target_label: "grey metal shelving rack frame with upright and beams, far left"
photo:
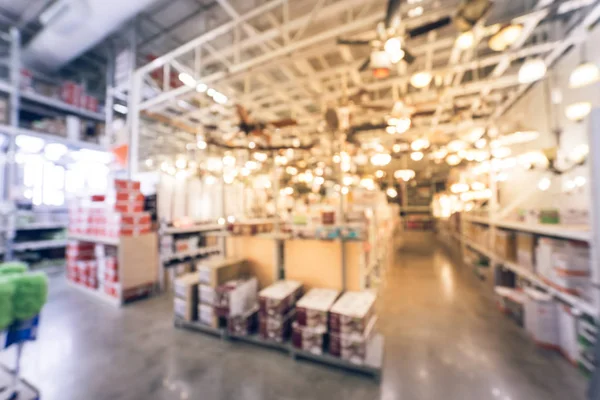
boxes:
[0,28,105,260]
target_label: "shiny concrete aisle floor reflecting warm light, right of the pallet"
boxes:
[381,237,587,400]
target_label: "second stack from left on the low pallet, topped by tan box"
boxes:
[196,258,246,328]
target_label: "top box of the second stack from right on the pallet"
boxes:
[296,289,340,331]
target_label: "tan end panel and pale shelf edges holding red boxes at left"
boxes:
[69,233,158,306]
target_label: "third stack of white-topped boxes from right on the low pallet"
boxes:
[258,281,302,343]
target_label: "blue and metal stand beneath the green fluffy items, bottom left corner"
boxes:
[0,316,40,400]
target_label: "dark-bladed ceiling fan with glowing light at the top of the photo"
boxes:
[337,0,491,78]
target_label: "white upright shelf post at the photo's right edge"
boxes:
[587,108,600,318]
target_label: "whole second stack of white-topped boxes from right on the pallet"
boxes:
[292,289,340,354]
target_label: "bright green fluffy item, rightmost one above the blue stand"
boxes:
[12,272,48,321]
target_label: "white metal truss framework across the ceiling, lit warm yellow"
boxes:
[130,0,598,170]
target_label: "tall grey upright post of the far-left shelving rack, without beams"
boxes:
[5,27,21,260]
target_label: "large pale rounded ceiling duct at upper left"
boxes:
[23,0,155,72]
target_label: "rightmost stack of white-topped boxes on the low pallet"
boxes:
[329,291,377,364]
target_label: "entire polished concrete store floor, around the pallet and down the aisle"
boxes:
[0,236,586,400]
